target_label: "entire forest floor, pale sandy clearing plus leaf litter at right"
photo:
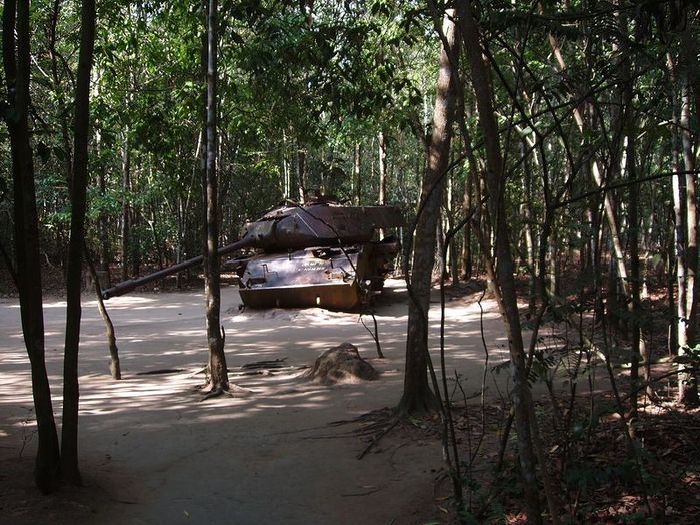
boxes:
[0,280,700,525]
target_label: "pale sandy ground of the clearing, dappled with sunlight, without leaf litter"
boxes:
[0,281,506,524]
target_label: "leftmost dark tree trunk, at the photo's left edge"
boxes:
[2,0,60,493]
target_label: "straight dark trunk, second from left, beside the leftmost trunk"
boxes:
[61,0,95,485]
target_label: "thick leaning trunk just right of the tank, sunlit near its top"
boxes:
[400,9,459,413]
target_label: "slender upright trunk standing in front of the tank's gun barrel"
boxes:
[204,0,229,392]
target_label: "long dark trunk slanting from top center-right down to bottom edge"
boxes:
[457,0,544,523]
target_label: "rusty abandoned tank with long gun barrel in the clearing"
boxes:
[102,197,403,311]
